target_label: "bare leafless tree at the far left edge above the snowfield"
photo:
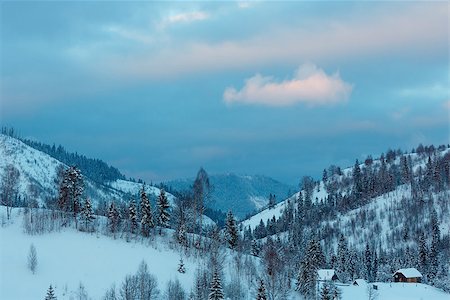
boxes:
[0,164,20,220]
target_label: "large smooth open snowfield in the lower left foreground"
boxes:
[0,207,196,300]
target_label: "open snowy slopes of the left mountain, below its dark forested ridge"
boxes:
[0,134,174,204]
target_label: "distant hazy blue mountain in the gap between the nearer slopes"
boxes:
[165,174,295,218]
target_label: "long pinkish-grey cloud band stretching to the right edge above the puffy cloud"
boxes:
[100,3,449,79]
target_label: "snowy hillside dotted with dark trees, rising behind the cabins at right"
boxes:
[237,145,450,299]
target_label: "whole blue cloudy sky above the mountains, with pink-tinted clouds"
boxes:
[0,1,450,184]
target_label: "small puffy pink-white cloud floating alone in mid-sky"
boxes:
[223,64,352,106]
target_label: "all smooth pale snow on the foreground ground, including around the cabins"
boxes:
[0,206,449,300]
